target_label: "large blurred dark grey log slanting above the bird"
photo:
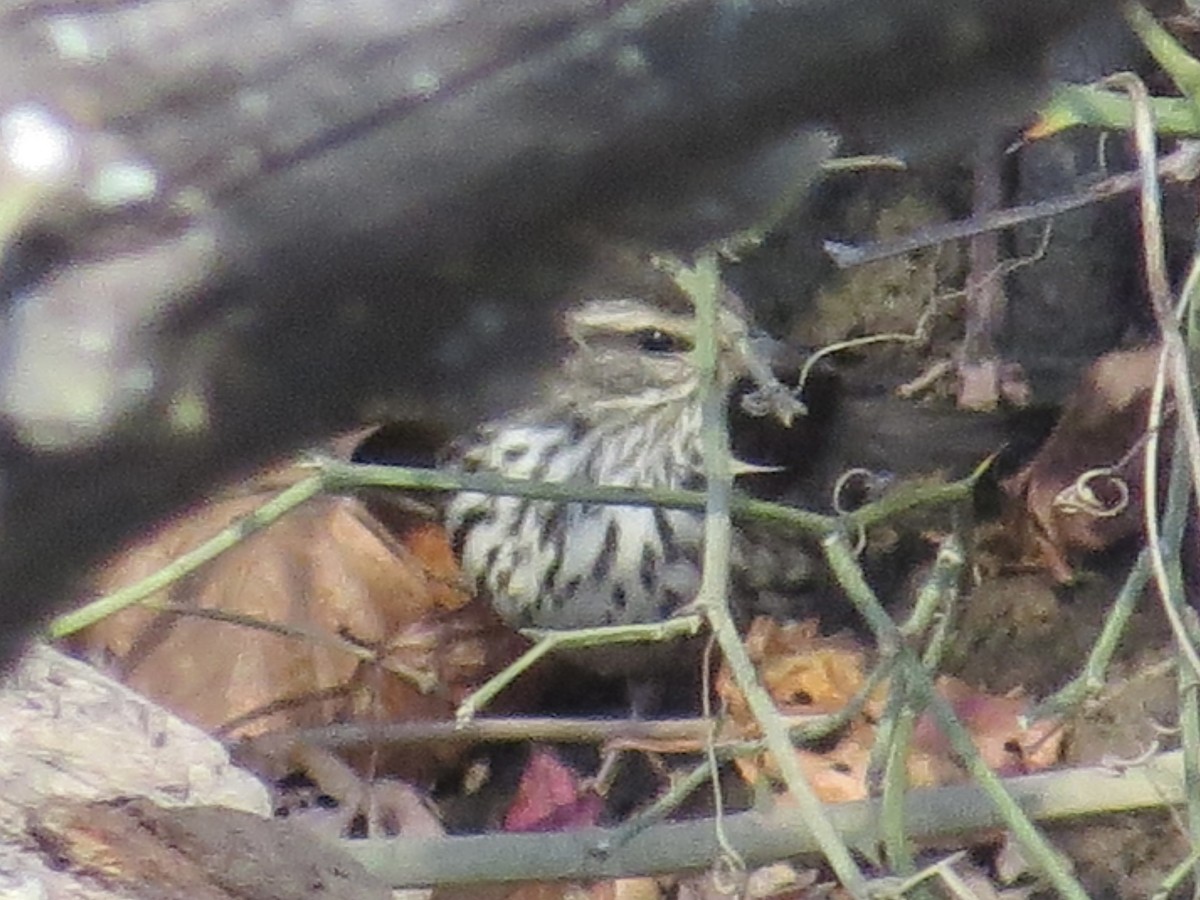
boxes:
[0,0,1108,656]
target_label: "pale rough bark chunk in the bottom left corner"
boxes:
[0,646,304,900]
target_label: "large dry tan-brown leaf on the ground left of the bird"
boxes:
[74,460,521,780]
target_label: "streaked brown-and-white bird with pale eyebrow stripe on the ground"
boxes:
[446,255,817,674]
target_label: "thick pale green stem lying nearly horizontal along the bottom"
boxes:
[348,751,1182,896]
